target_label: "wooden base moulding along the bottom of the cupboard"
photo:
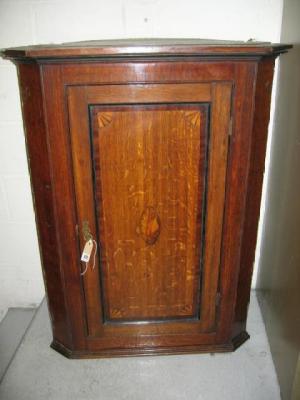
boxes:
[50,331,250,359]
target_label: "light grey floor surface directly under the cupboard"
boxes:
[0,294,280,400]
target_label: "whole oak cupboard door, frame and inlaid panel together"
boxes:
[67,82,232,349]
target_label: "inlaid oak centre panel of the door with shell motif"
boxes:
[91,104,209,321]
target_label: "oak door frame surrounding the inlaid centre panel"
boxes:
[67,82,232,345]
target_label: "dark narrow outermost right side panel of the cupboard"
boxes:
[235,58,274,331]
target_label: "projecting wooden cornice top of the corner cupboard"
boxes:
[0,39,292,59]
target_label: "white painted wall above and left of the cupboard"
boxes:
[0,0,282,319]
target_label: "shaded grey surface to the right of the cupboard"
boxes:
[257,43,300,400]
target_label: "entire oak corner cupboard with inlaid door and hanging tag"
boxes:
[2,39,291,358]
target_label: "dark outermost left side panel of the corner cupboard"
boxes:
[18,63,70,345]
